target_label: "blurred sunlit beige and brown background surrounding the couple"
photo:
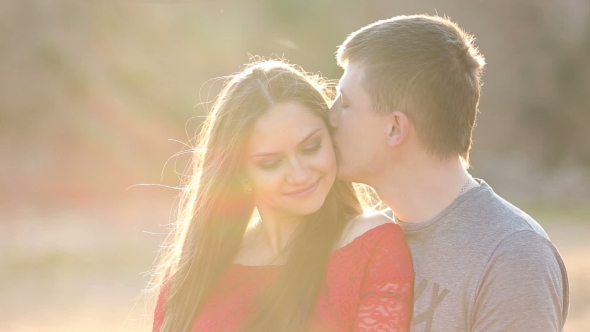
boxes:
[0,0,590,332]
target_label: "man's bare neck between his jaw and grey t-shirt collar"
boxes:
[374,158,478,223]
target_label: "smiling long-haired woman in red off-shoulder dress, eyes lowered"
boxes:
[154,61,413,332]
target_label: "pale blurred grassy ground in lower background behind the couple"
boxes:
[0,202,590,332]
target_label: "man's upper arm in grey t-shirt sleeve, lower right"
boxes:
[471,231,569,332]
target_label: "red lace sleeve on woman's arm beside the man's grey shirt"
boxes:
[354,225,414,332]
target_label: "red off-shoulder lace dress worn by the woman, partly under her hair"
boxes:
[153,224,414,332]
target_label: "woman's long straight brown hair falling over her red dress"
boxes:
[156,60,362,332]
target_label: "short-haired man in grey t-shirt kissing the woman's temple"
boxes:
[331,15,569,332]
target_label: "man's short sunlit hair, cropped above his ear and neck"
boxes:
[337,15,485,163]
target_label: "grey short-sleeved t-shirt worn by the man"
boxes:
[399,180,569,332]
